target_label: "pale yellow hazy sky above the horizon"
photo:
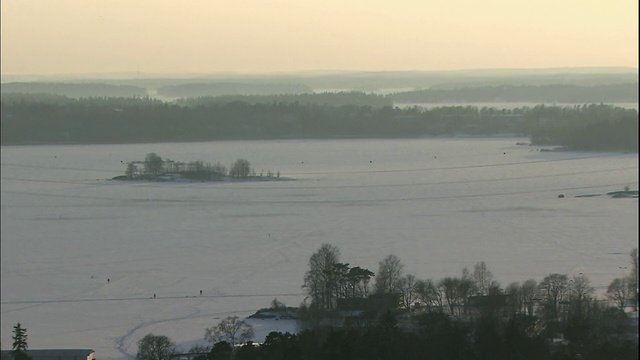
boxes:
[1,0,638,75]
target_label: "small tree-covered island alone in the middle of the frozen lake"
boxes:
[113,153,284,181]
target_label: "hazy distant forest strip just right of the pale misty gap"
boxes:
[158,82,312,98]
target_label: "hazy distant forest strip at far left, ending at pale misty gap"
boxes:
[2,82,147,98]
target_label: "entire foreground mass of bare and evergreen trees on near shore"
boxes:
[156,244,638,360]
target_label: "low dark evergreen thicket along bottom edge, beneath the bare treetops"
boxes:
[215,311,638,360]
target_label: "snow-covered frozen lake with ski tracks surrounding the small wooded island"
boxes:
[1,138,638,360]
